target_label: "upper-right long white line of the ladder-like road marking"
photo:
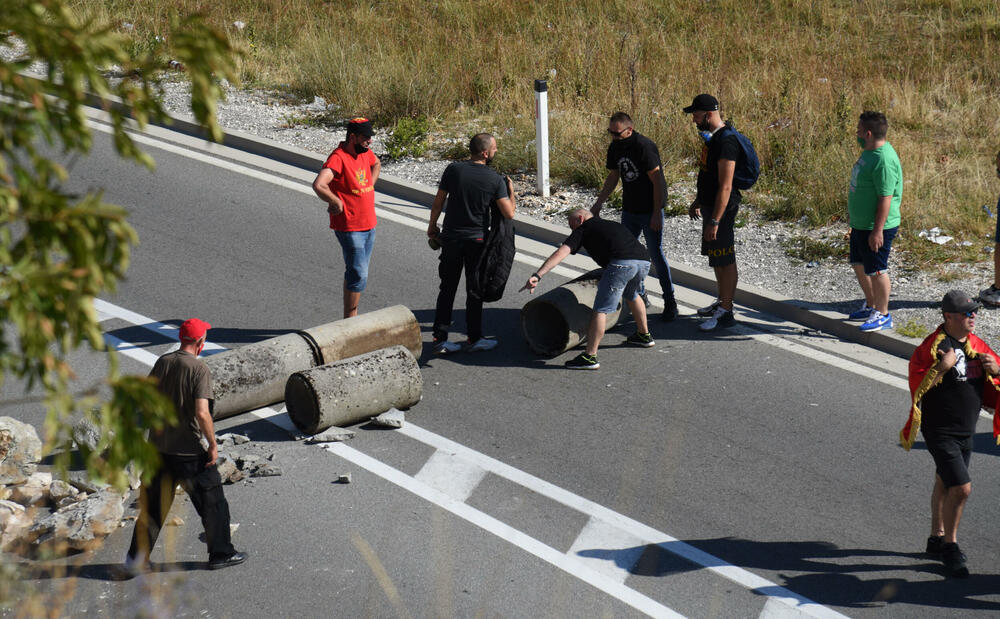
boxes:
[397,423,844,617]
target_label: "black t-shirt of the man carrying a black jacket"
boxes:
[438,159,509,239]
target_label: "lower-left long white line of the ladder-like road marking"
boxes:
[323,443,684,617]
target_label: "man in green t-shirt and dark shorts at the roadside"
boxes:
[847,112,903,332]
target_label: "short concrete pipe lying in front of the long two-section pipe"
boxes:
[285,346,423,434]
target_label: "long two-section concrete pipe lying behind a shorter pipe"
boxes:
[205,305,422,420]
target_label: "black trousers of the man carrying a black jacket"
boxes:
[434,239,483,342]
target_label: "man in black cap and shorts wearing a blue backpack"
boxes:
[684,94,745,331]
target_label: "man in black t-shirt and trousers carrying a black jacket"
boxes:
[427,133,514,354]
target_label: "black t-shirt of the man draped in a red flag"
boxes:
[920,334,986,435]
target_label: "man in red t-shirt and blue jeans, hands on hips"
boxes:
[313,118,382,318]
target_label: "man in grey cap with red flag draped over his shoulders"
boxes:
[904,290,1000,577]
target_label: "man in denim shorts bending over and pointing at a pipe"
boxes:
[521,209,656,370]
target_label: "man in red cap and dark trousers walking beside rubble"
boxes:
[125,318,247,576]
